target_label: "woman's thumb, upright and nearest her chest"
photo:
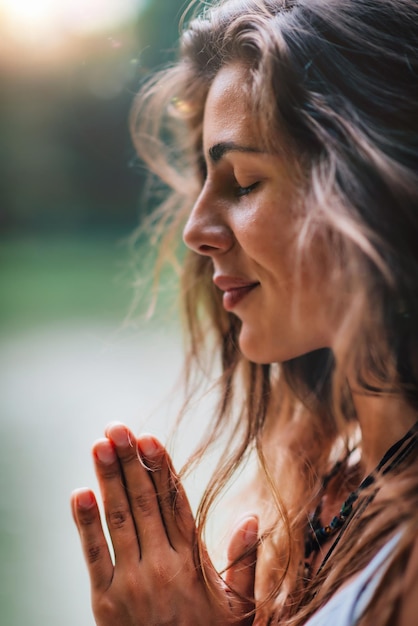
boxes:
[225,516,258,613]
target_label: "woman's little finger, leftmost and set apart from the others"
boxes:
[71,489,113,590]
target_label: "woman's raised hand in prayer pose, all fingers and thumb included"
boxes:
[72,424,257,626]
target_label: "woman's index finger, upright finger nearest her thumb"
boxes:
[138,435,196,551]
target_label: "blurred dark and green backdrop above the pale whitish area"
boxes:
[0,0,187,331]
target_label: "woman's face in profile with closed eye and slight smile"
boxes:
[184,64,336,363]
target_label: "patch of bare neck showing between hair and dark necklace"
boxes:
[352,391,418,475]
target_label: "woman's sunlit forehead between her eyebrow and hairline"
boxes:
[203,64,257,152]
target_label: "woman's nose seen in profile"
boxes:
[183,190,234,256]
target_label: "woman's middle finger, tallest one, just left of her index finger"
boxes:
[106,423,169,557]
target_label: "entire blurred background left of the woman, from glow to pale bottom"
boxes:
[0,0,212,626]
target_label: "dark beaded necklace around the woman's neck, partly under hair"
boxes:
[305,422,418,579]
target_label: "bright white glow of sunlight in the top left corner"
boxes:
[0,0,148,41]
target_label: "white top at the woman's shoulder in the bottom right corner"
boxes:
[305,533,401,626]
